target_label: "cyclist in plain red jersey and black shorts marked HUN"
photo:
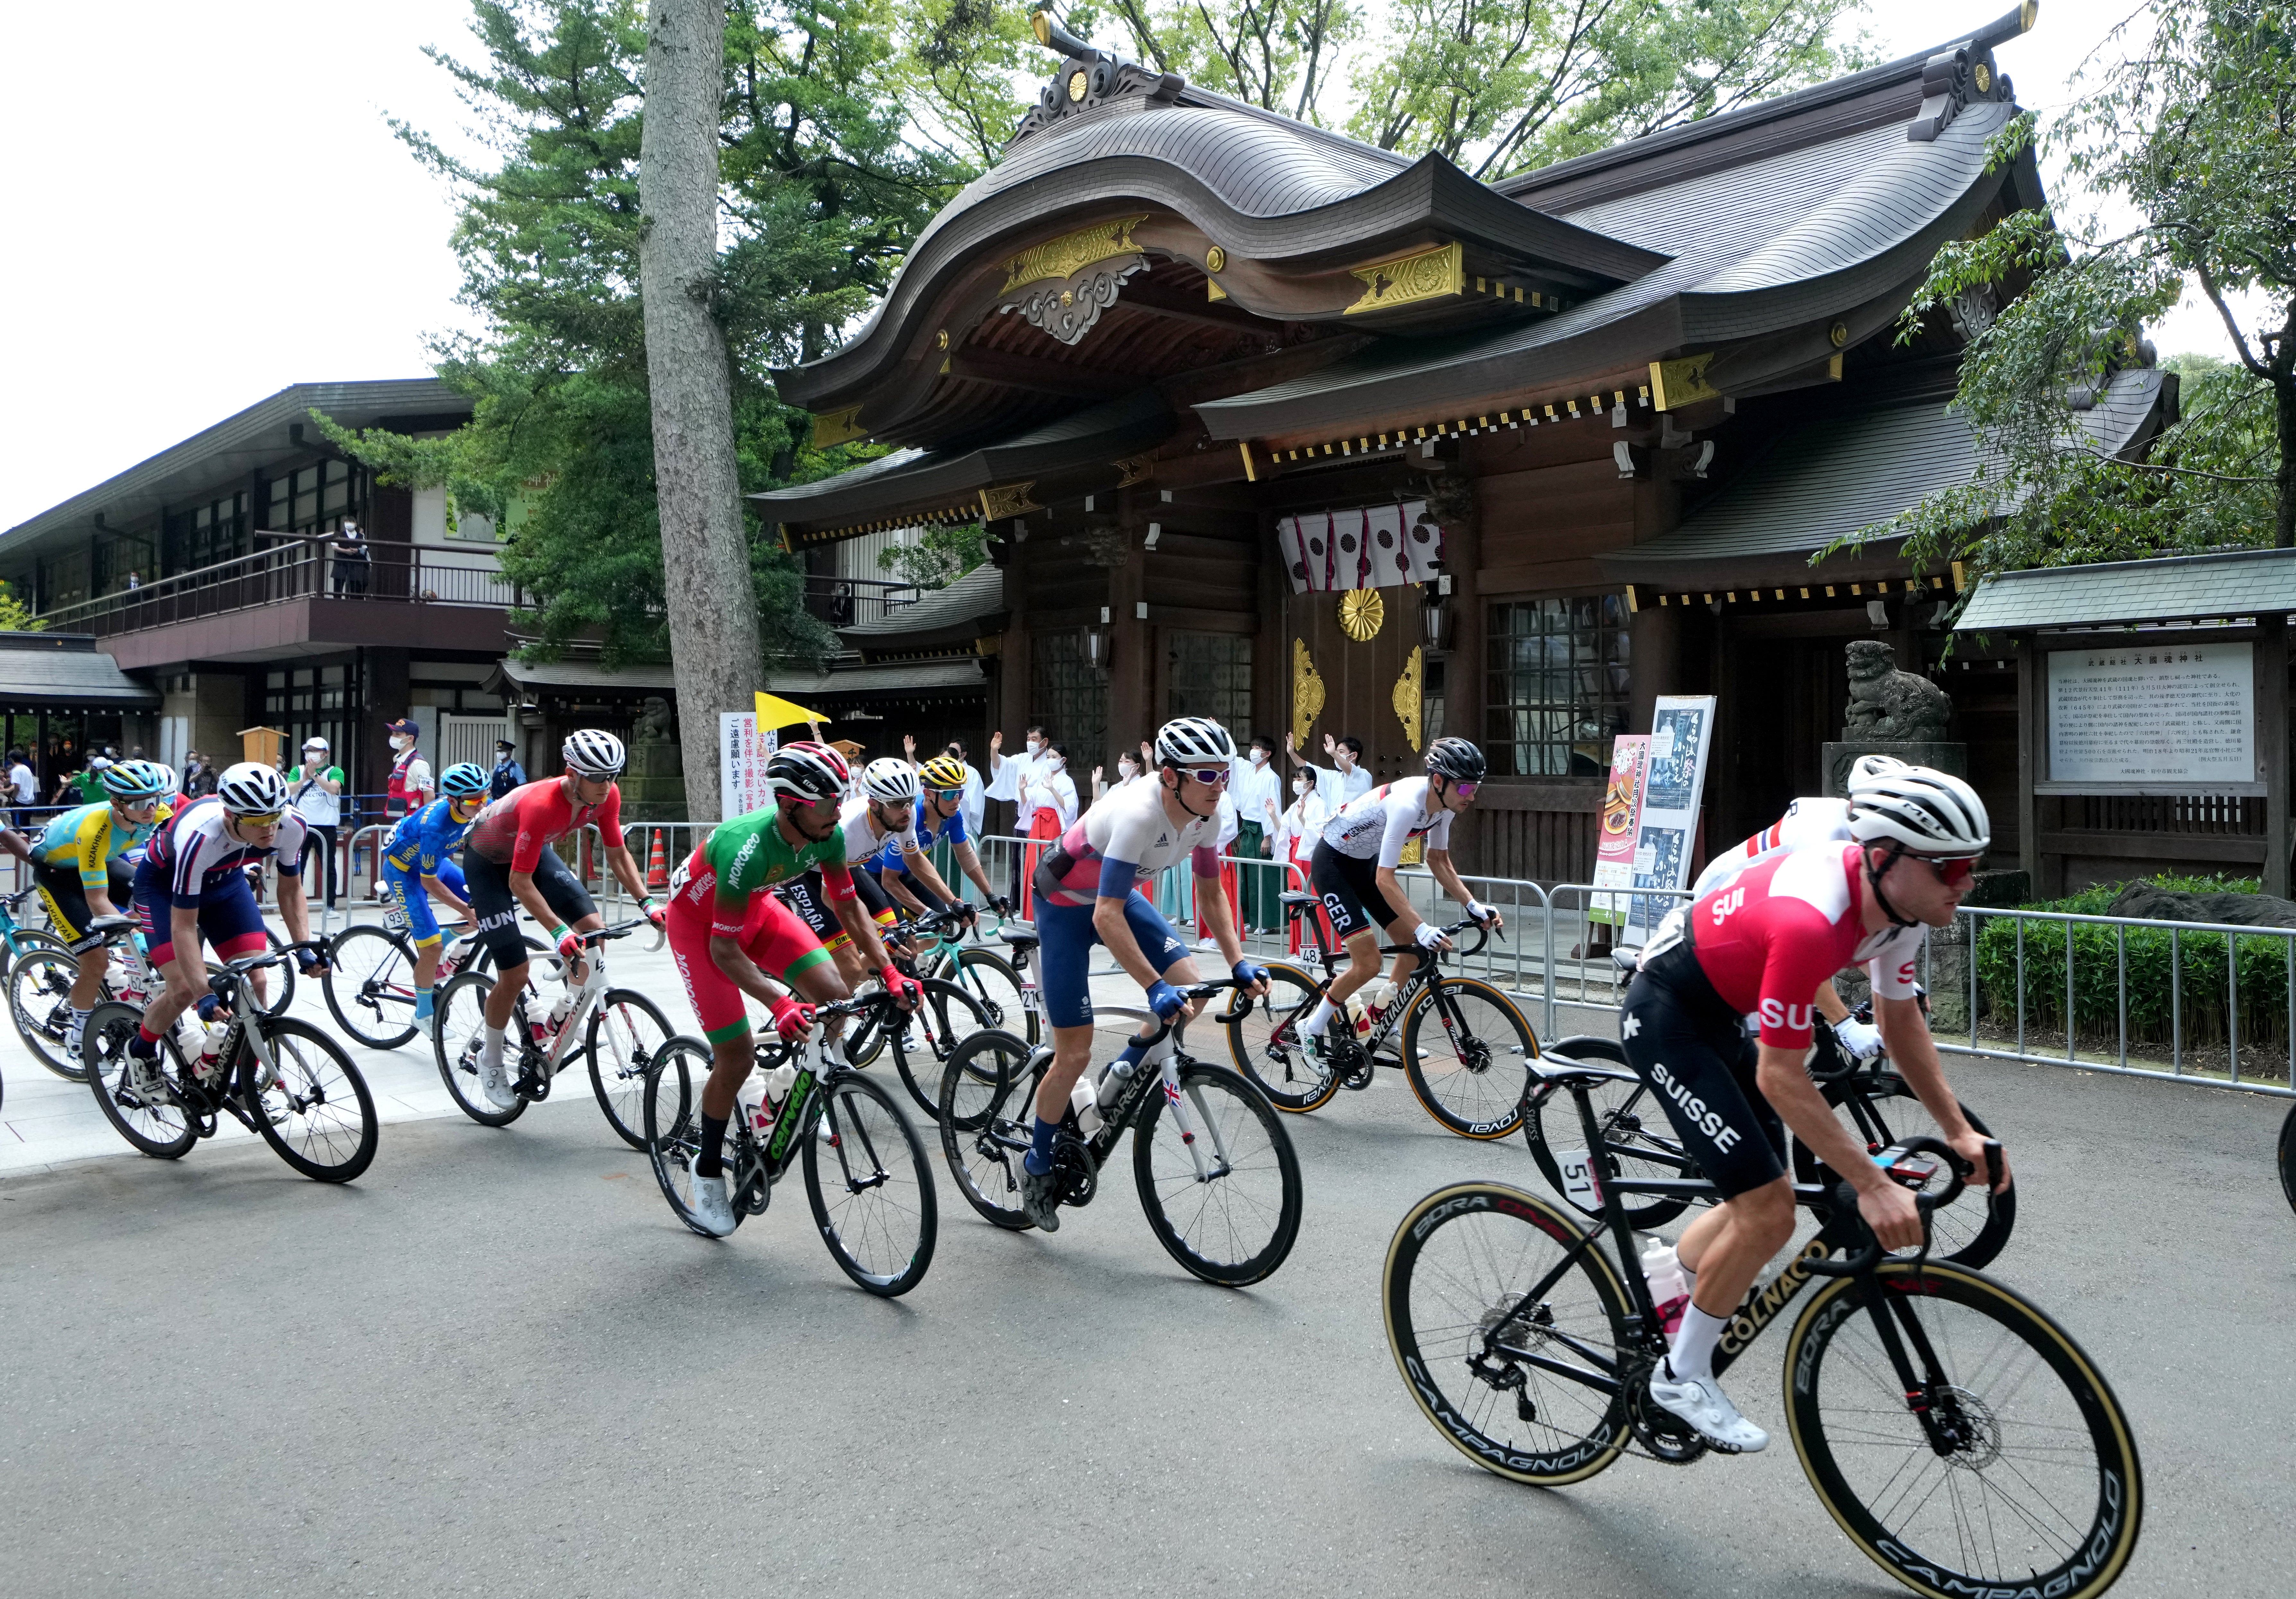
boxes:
[462,728,668,1110]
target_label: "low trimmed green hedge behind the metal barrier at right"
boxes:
[1977,875,2289,1057]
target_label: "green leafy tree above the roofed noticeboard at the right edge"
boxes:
[1853,0,2296,572]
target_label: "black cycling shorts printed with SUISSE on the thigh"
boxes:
[1619,944,1786,1197]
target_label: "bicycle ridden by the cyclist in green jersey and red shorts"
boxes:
[640,992,939,1298]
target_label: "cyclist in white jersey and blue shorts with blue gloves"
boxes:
[1019,717,1267,1231]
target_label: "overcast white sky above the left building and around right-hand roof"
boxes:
[0,0,2230,529]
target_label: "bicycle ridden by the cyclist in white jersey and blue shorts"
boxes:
[939,960,1304,1287]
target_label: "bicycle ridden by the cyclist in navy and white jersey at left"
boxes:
[80,919,381,1183]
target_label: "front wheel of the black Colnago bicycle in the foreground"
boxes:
[1786,1261,2144,1599]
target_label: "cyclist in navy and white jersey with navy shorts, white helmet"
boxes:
[129,760,321,1094]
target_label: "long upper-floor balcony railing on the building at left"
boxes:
[41,542,524,636]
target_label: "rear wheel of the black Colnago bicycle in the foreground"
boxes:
[1380,1183,1632,1489]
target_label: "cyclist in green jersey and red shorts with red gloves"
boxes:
[668,740,923,1238]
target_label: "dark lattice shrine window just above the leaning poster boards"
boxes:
[1483,595,1628,776]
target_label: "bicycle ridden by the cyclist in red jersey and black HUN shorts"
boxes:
[432,917,670,1149]
